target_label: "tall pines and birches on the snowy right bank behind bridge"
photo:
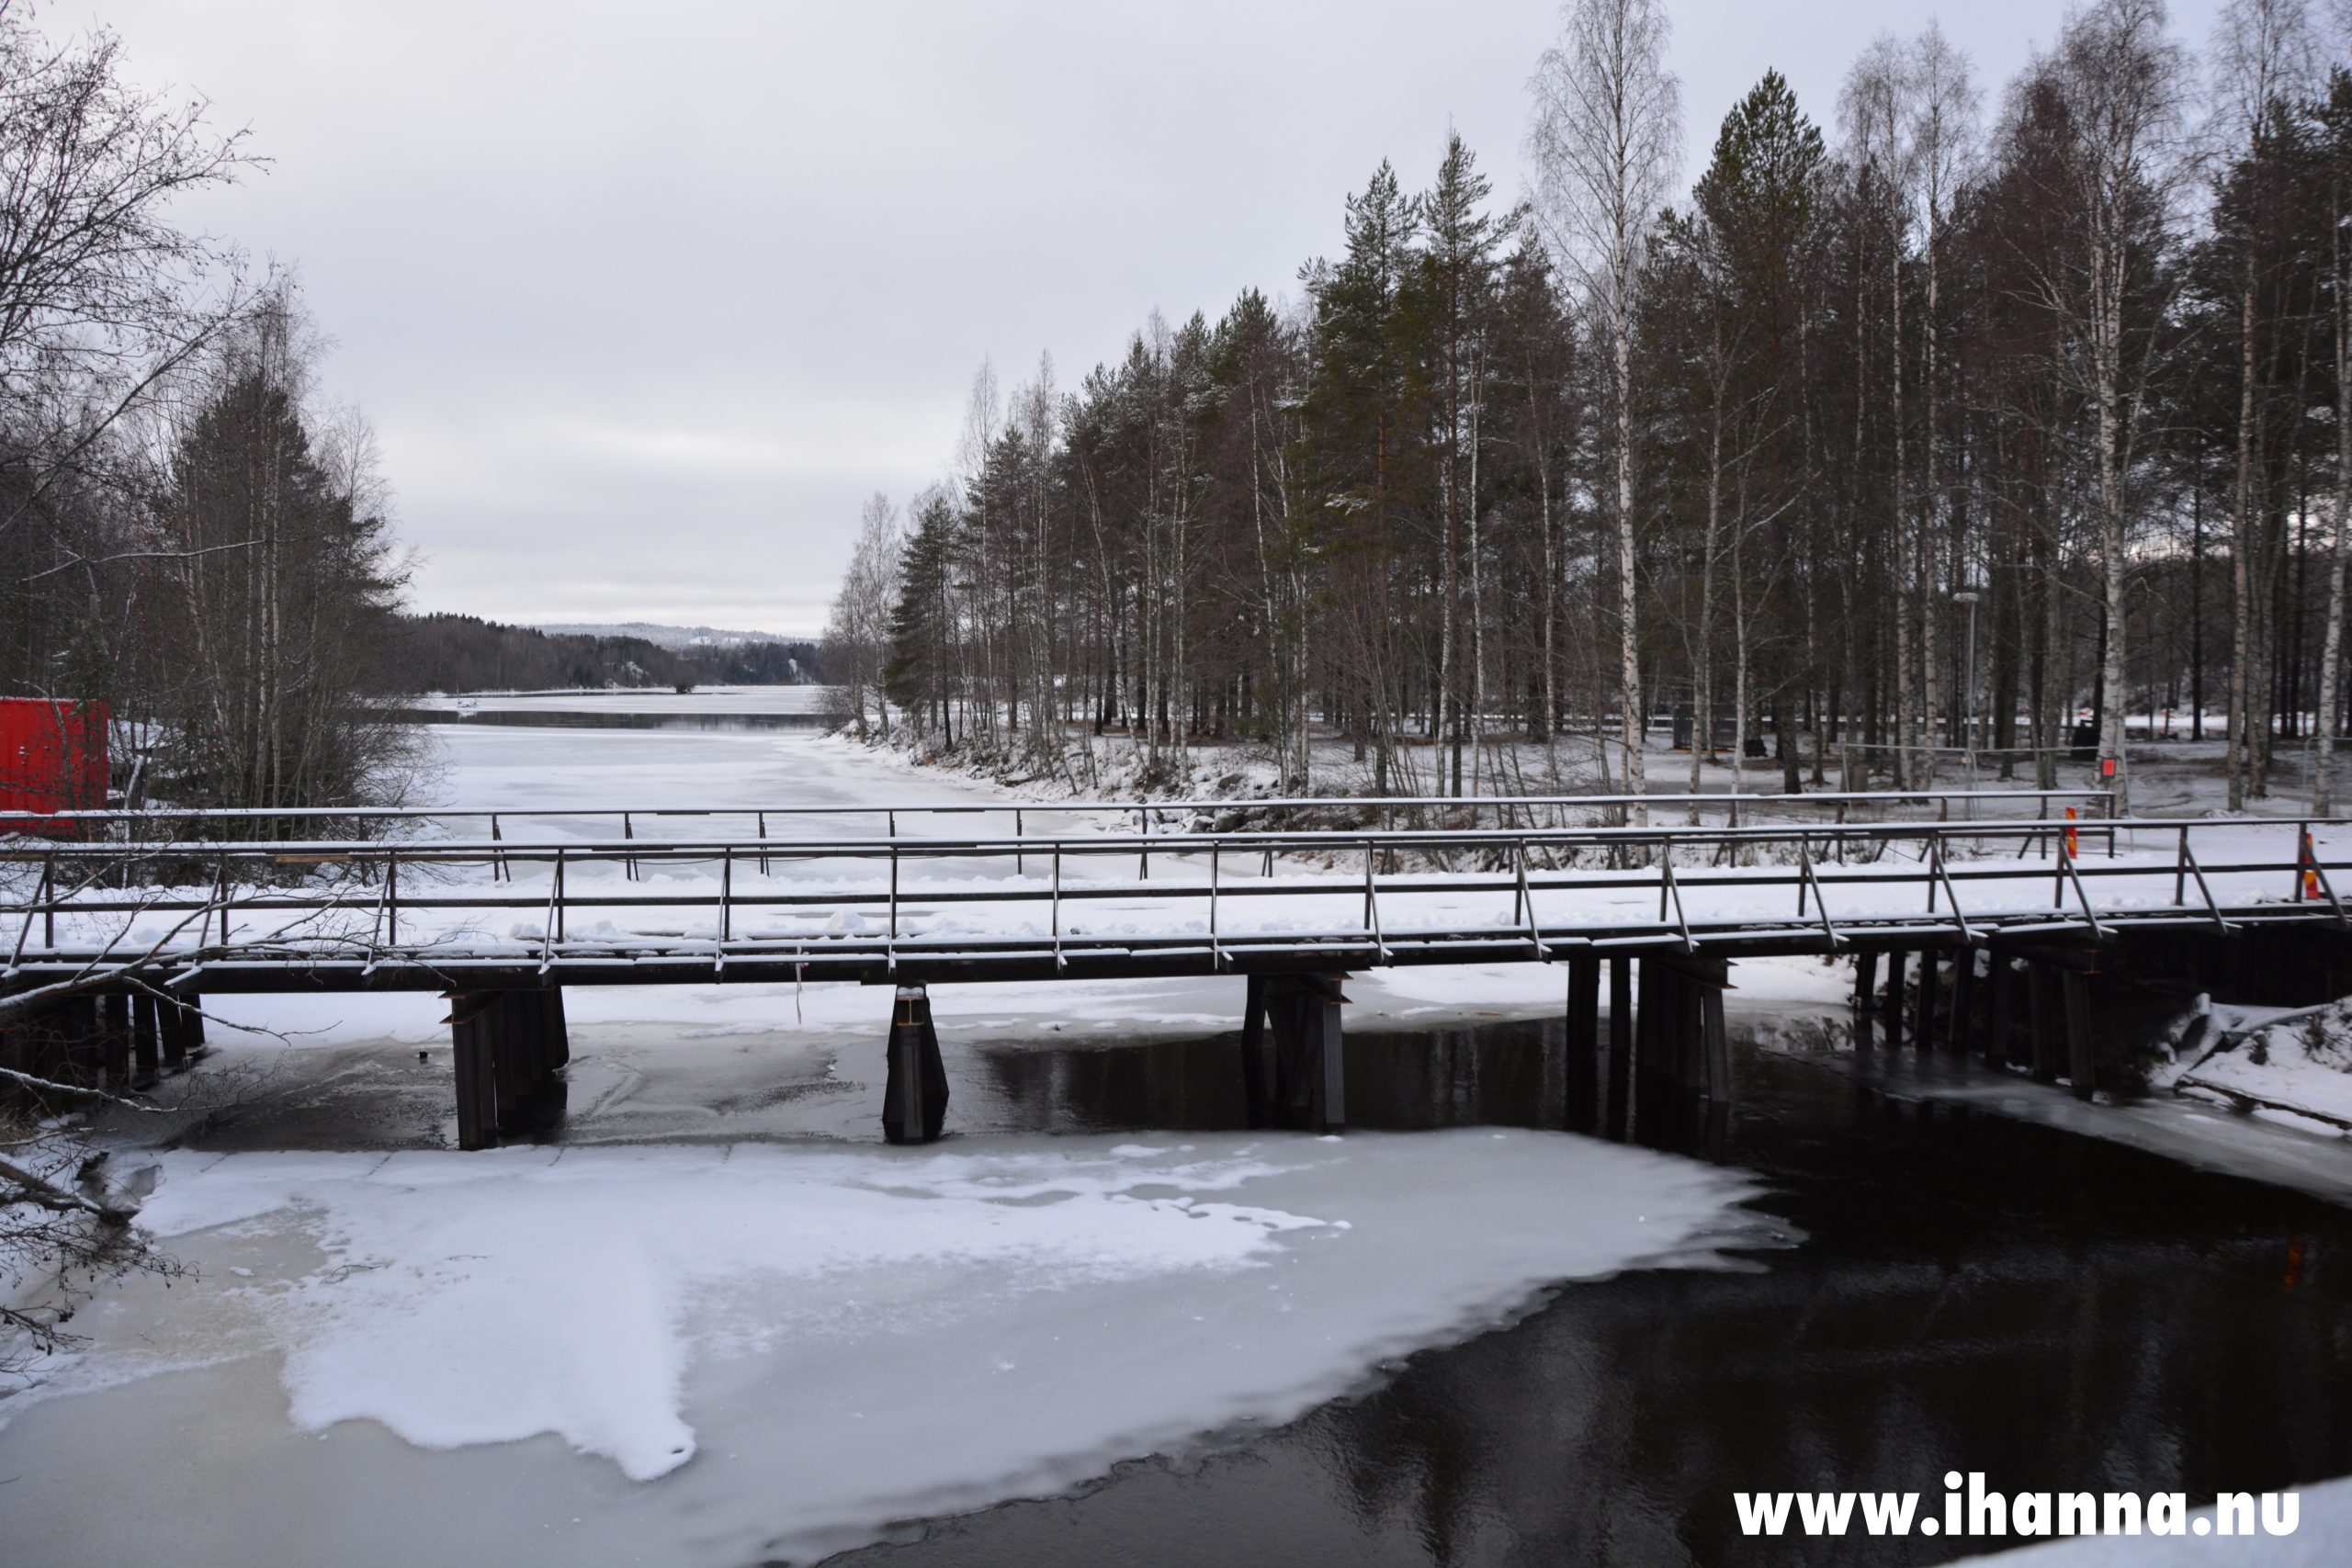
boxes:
[828,0,2352,804]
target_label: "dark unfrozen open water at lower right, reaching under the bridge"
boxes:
[832,1025,2352,1568]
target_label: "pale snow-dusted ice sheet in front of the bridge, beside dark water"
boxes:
[59,1128,1755,1559]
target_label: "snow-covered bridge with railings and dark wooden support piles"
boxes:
[0,792,2352,1147]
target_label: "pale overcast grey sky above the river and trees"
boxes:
[55,0,2216,632]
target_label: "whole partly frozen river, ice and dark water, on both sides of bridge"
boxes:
[0,696,2352,1568]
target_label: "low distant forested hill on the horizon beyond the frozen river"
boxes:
[390,616,819,694]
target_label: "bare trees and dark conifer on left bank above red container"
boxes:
[0,3,416,822]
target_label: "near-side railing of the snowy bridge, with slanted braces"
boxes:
[0,818,2352,987]
